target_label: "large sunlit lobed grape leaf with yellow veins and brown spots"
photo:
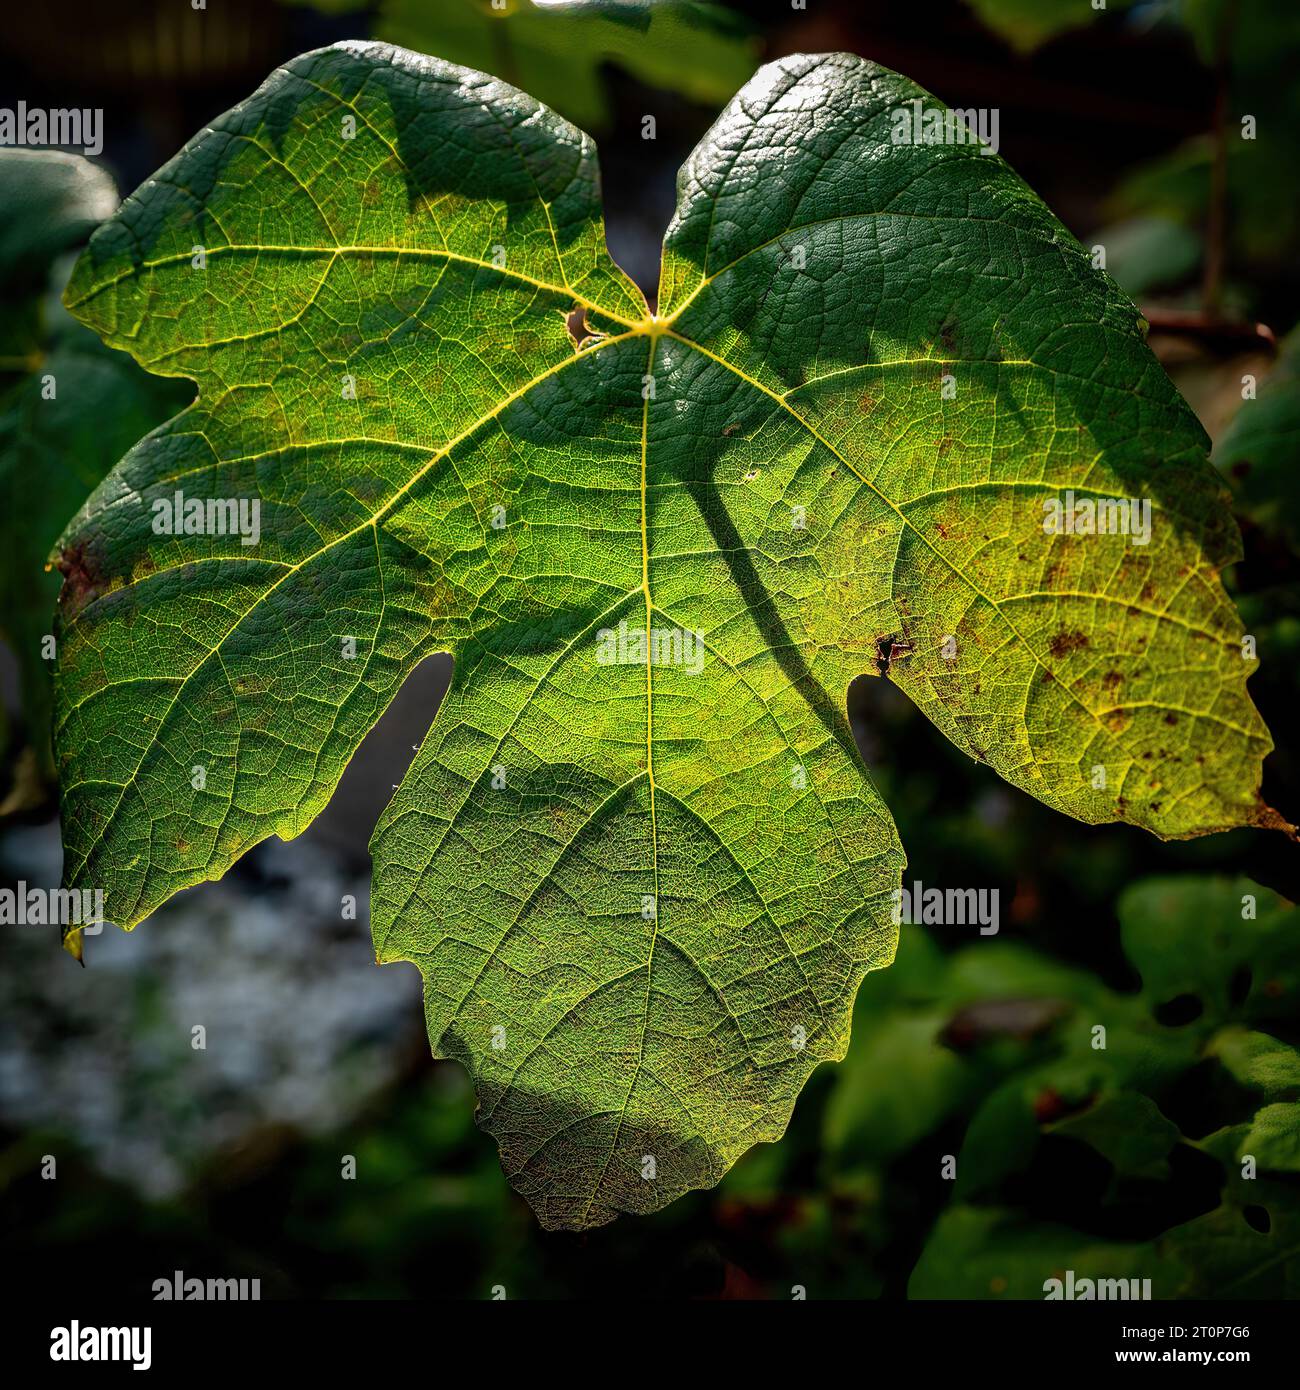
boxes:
[57,43,1278,1227]
